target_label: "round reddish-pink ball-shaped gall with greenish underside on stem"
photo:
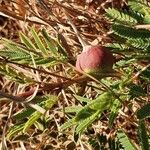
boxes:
[76,45,114,73]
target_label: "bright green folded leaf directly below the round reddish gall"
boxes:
[61,92,113,134]
